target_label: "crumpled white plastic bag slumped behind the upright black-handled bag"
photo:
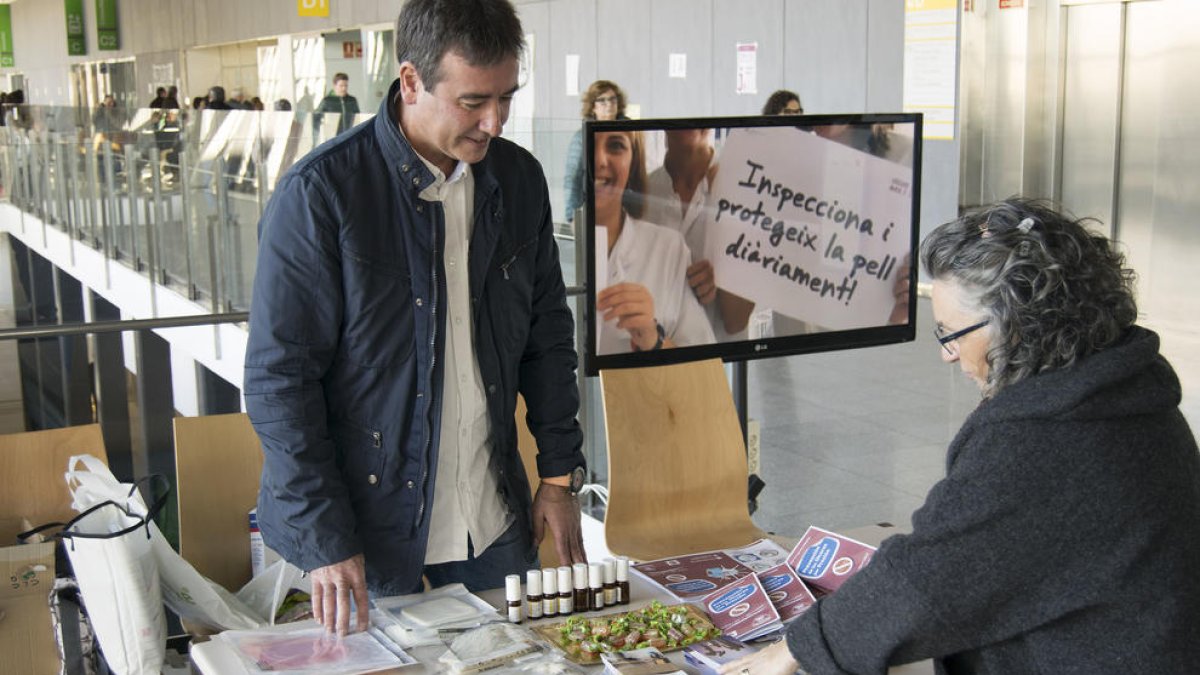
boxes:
[66,455,265,631]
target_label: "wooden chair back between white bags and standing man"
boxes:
[175,413,263,592]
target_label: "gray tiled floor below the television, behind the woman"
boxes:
[750,298,1200,536]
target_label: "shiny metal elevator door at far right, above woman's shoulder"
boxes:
[1057,0,1200,321]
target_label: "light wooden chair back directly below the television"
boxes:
[600,359,767,560]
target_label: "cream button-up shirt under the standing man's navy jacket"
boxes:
[420,157,512,565]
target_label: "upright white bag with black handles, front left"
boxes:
[62,482,167,675]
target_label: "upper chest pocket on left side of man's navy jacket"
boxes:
[341,249,414,368]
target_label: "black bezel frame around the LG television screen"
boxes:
[582,113,923,376]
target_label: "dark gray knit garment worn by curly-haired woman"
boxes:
[787,328,1200,675]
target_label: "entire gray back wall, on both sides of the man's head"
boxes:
[0,0,959,234]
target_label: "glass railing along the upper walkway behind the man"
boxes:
[0,106,588,311]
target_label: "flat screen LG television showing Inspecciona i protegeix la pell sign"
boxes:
[583,113,922,375]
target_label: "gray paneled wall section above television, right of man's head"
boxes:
[518,0,960,232]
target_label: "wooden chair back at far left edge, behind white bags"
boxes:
[0,424,108,546]
